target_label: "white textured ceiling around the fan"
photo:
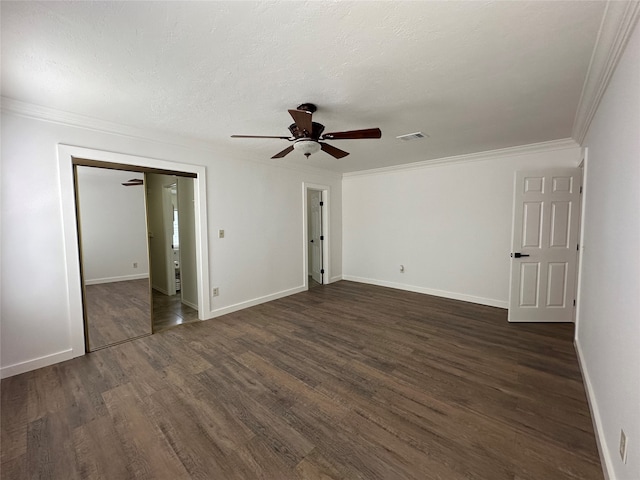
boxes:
[1,1,606,172]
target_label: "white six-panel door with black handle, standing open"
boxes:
[509,168,582,322]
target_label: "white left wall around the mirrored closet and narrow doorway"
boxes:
[0,109,342,376]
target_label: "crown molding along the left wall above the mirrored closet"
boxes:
[0,97,342,179]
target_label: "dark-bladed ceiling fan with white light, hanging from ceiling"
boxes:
[231,103,382,158]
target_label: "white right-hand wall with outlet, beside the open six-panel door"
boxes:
[576,17,640,480]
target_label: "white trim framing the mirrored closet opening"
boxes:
[58,144,211,357]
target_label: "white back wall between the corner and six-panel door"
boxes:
[343,142,580,308]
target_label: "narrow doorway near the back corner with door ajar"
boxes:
[303,184,330,289]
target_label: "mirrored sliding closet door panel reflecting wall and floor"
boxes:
[76,166,152,351]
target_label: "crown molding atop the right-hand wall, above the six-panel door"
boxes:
[571,0,640,144]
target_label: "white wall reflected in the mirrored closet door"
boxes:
[78,167,149,285]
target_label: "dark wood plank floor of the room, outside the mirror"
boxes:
[1,281,603,480]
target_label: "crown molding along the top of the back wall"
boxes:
[342,138,579,178]
